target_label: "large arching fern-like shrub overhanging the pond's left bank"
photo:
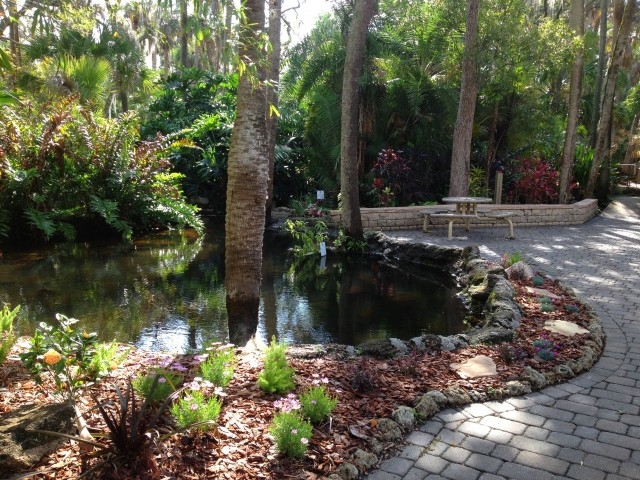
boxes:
[0,97,203,241]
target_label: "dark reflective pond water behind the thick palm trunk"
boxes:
[0,231,466,353]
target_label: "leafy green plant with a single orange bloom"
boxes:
[20,313,98,398]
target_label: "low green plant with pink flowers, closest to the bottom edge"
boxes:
[269,398,313,458]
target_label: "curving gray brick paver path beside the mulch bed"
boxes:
[367,197,640,480]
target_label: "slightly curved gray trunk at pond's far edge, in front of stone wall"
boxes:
[340,0,376,239]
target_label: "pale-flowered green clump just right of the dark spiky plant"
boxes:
[171,390,222,431]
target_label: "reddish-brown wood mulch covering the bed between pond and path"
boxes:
[0,274,590,480]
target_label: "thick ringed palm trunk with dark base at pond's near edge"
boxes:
[225,0,269,345]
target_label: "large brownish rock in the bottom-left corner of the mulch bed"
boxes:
[0,403,75,476]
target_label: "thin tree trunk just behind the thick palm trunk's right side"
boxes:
[265,0,282,224]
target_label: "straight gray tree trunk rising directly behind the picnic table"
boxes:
[449,0,480,197]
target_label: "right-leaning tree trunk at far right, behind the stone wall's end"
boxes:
[585,0,636,198]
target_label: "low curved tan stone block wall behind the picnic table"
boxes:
[329,199,598,230]
